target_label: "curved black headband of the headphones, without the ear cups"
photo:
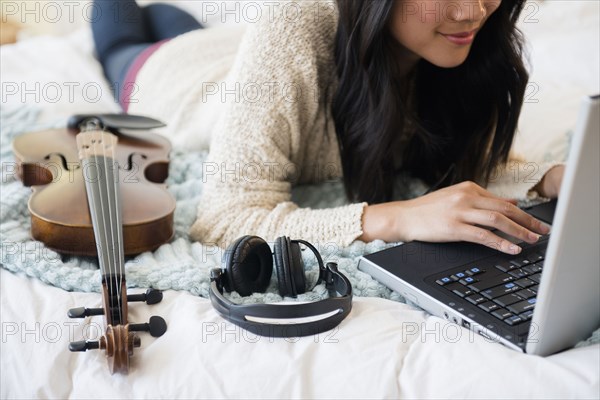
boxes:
[210,239,352,337]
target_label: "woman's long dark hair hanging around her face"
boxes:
[332,0,528,203]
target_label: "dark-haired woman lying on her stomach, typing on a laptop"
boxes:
[94,0,563,254]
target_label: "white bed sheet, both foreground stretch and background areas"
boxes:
[0,1,600,398]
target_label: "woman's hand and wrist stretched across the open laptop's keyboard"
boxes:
[360,182,550,254]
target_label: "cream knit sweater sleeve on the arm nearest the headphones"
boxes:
[190,2,366,247]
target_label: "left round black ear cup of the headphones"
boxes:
[225,236,273,296]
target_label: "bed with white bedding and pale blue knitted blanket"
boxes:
[0,1,600,399]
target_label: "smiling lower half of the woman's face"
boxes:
[390,0,502,68]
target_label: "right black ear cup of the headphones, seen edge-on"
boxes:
[275,236,306,297]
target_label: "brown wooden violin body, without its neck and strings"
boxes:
[13,119,175,256]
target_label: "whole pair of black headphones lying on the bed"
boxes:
[210,236,352,337]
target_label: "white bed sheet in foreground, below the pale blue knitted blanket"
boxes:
[0,270,600,398]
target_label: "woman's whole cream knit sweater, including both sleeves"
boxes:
[130,1,554,246]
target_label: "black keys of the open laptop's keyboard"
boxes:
[435,243,547,326]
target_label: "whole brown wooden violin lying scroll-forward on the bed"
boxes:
[13,115,175,373]
